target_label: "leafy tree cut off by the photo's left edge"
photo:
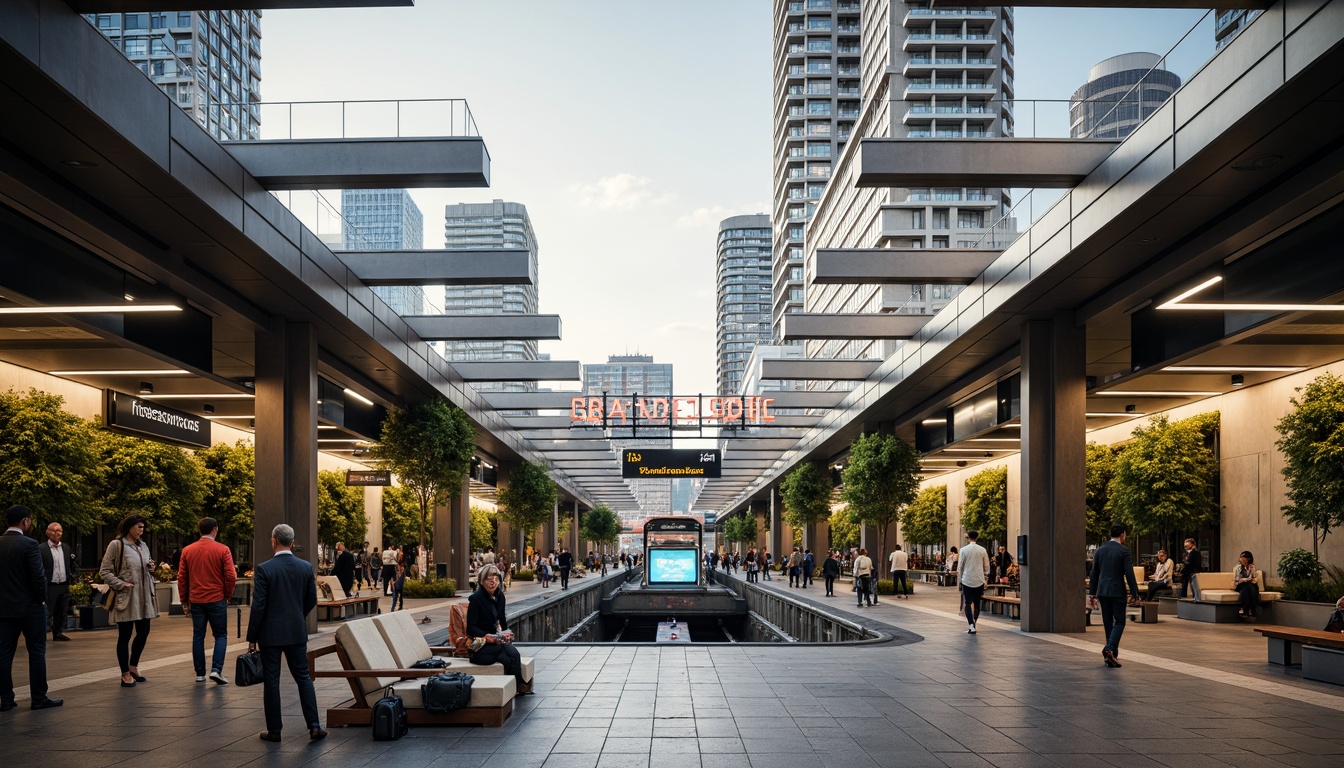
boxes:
[0,389,106,541]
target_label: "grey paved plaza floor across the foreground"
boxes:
[0,567,1344,768]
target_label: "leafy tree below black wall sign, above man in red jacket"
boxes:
[98,432,206,534]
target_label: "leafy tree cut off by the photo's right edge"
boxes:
[1274,373,1344,555]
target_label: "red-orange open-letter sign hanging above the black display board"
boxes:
[570,395,774,428]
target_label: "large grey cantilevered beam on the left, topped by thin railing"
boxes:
[223,136,491,190]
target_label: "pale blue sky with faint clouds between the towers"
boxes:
[261,0,1212,394]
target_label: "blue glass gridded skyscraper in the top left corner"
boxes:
[85,11,261,141]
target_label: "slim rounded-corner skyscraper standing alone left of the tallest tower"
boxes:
[715,214,771,394]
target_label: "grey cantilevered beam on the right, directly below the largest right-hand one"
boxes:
[812,247,1003,285]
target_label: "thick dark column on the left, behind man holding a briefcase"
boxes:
[253,319,317,632]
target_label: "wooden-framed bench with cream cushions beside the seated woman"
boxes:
[308,613,517,728]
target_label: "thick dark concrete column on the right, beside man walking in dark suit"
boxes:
[1008,312,1086,632]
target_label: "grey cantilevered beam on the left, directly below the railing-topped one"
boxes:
[335,247,536,285]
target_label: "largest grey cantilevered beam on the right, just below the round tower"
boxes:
[857,139,1120,188]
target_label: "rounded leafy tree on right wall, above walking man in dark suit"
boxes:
[1107,413,1219,542]
